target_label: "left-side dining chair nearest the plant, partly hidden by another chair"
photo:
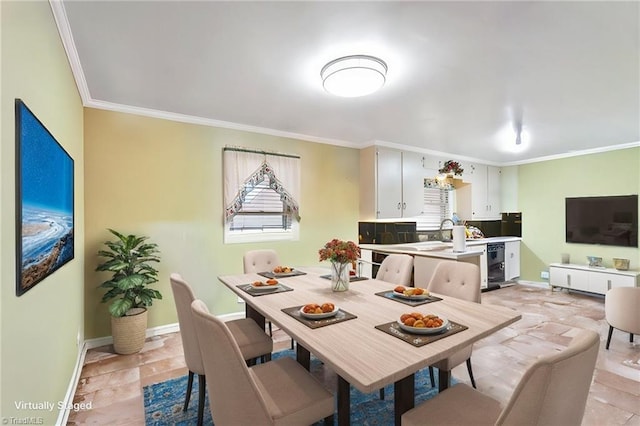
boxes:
[169,273,273,425]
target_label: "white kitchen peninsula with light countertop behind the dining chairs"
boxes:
[360,237,521,289]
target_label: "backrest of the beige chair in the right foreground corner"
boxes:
[496,330,600,425]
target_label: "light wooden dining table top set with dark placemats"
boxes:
[218,268,521,393]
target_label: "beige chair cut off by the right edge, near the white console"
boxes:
[604,287,640,349]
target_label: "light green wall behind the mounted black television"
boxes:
[518,148,640,281]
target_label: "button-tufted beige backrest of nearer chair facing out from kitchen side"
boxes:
[427,260,480,303]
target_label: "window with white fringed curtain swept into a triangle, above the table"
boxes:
[223,147,300,243]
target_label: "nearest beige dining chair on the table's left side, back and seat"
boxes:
[191,300,334,426]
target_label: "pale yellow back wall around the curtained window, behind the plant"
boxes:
[85,108,359,338]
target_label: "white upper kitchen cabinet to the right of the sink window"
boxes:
[456,164,501,220]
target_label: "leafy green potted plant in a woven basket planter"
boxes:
[96,229,162,354]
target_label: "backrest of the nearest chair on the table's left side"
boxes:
[191,300,273,425]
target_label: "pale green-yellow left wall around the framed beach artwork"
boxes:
[0,1,84,424]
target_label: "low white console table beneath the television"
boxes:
[549,263,640,294]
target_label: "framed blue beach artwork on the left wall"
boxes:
[15,99,74,296]
